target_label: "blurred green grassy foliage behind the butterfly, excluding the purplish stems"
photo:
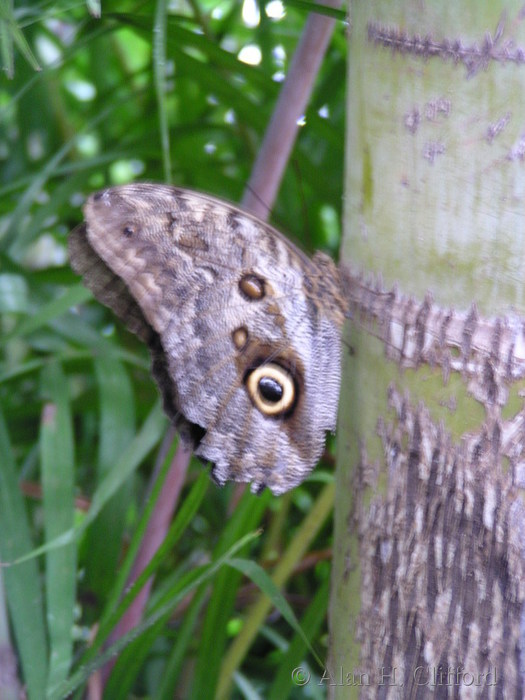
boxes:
[0,0,346,699]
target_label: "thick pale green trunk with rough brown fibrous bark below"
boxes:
[332,0,525,700]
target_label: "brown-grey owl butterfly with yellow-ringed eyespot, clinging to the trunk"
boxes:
[69,184,345,494]
